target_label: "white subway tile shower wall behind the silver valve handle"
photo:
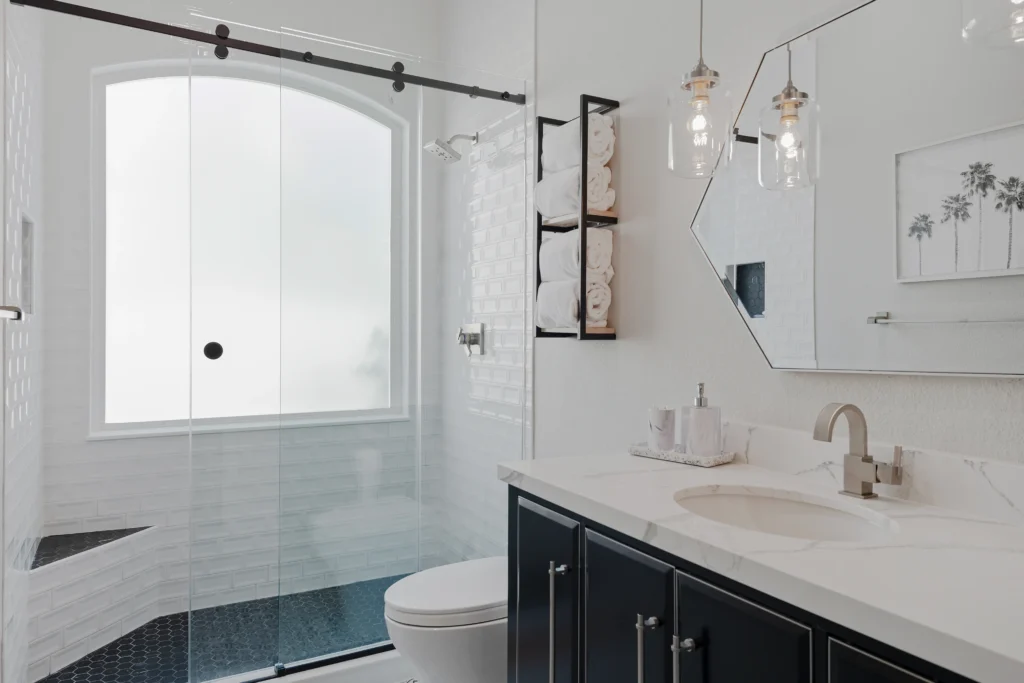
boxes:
[436,111,534,563]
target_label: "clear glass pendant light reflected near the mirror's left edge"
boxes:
[758,43,818,190]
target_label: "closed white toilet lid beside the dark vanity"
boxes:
[384,557,508,627]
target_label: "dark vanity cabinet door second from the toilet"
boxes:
[584,529,675,683]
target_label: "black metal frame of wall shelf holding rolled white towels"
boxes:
[535,95,620,341]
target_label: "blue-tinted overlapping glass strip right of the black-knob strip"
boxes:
[280,29,421,666]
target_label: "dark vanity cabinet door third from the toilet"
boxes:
[676,572,811,683]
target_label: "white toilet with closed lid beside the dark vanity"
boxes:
[384,557,508,683]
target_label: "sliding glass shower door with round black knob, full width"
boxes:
[189,25,422,682]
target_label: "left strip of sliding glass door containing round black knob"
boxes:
[189,17,282,683]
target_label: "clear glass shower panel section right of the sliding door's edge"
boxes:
[420,65,536,568]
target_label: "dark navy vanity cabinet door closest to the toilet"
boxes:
[516,499,582,683]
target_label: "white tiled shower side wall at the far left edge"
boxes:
[2,7,46,683]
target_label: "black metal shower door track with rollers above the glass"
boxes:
[10,0,526,104]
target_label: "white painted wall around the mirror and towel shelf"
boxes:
[535,0,1024,461]
